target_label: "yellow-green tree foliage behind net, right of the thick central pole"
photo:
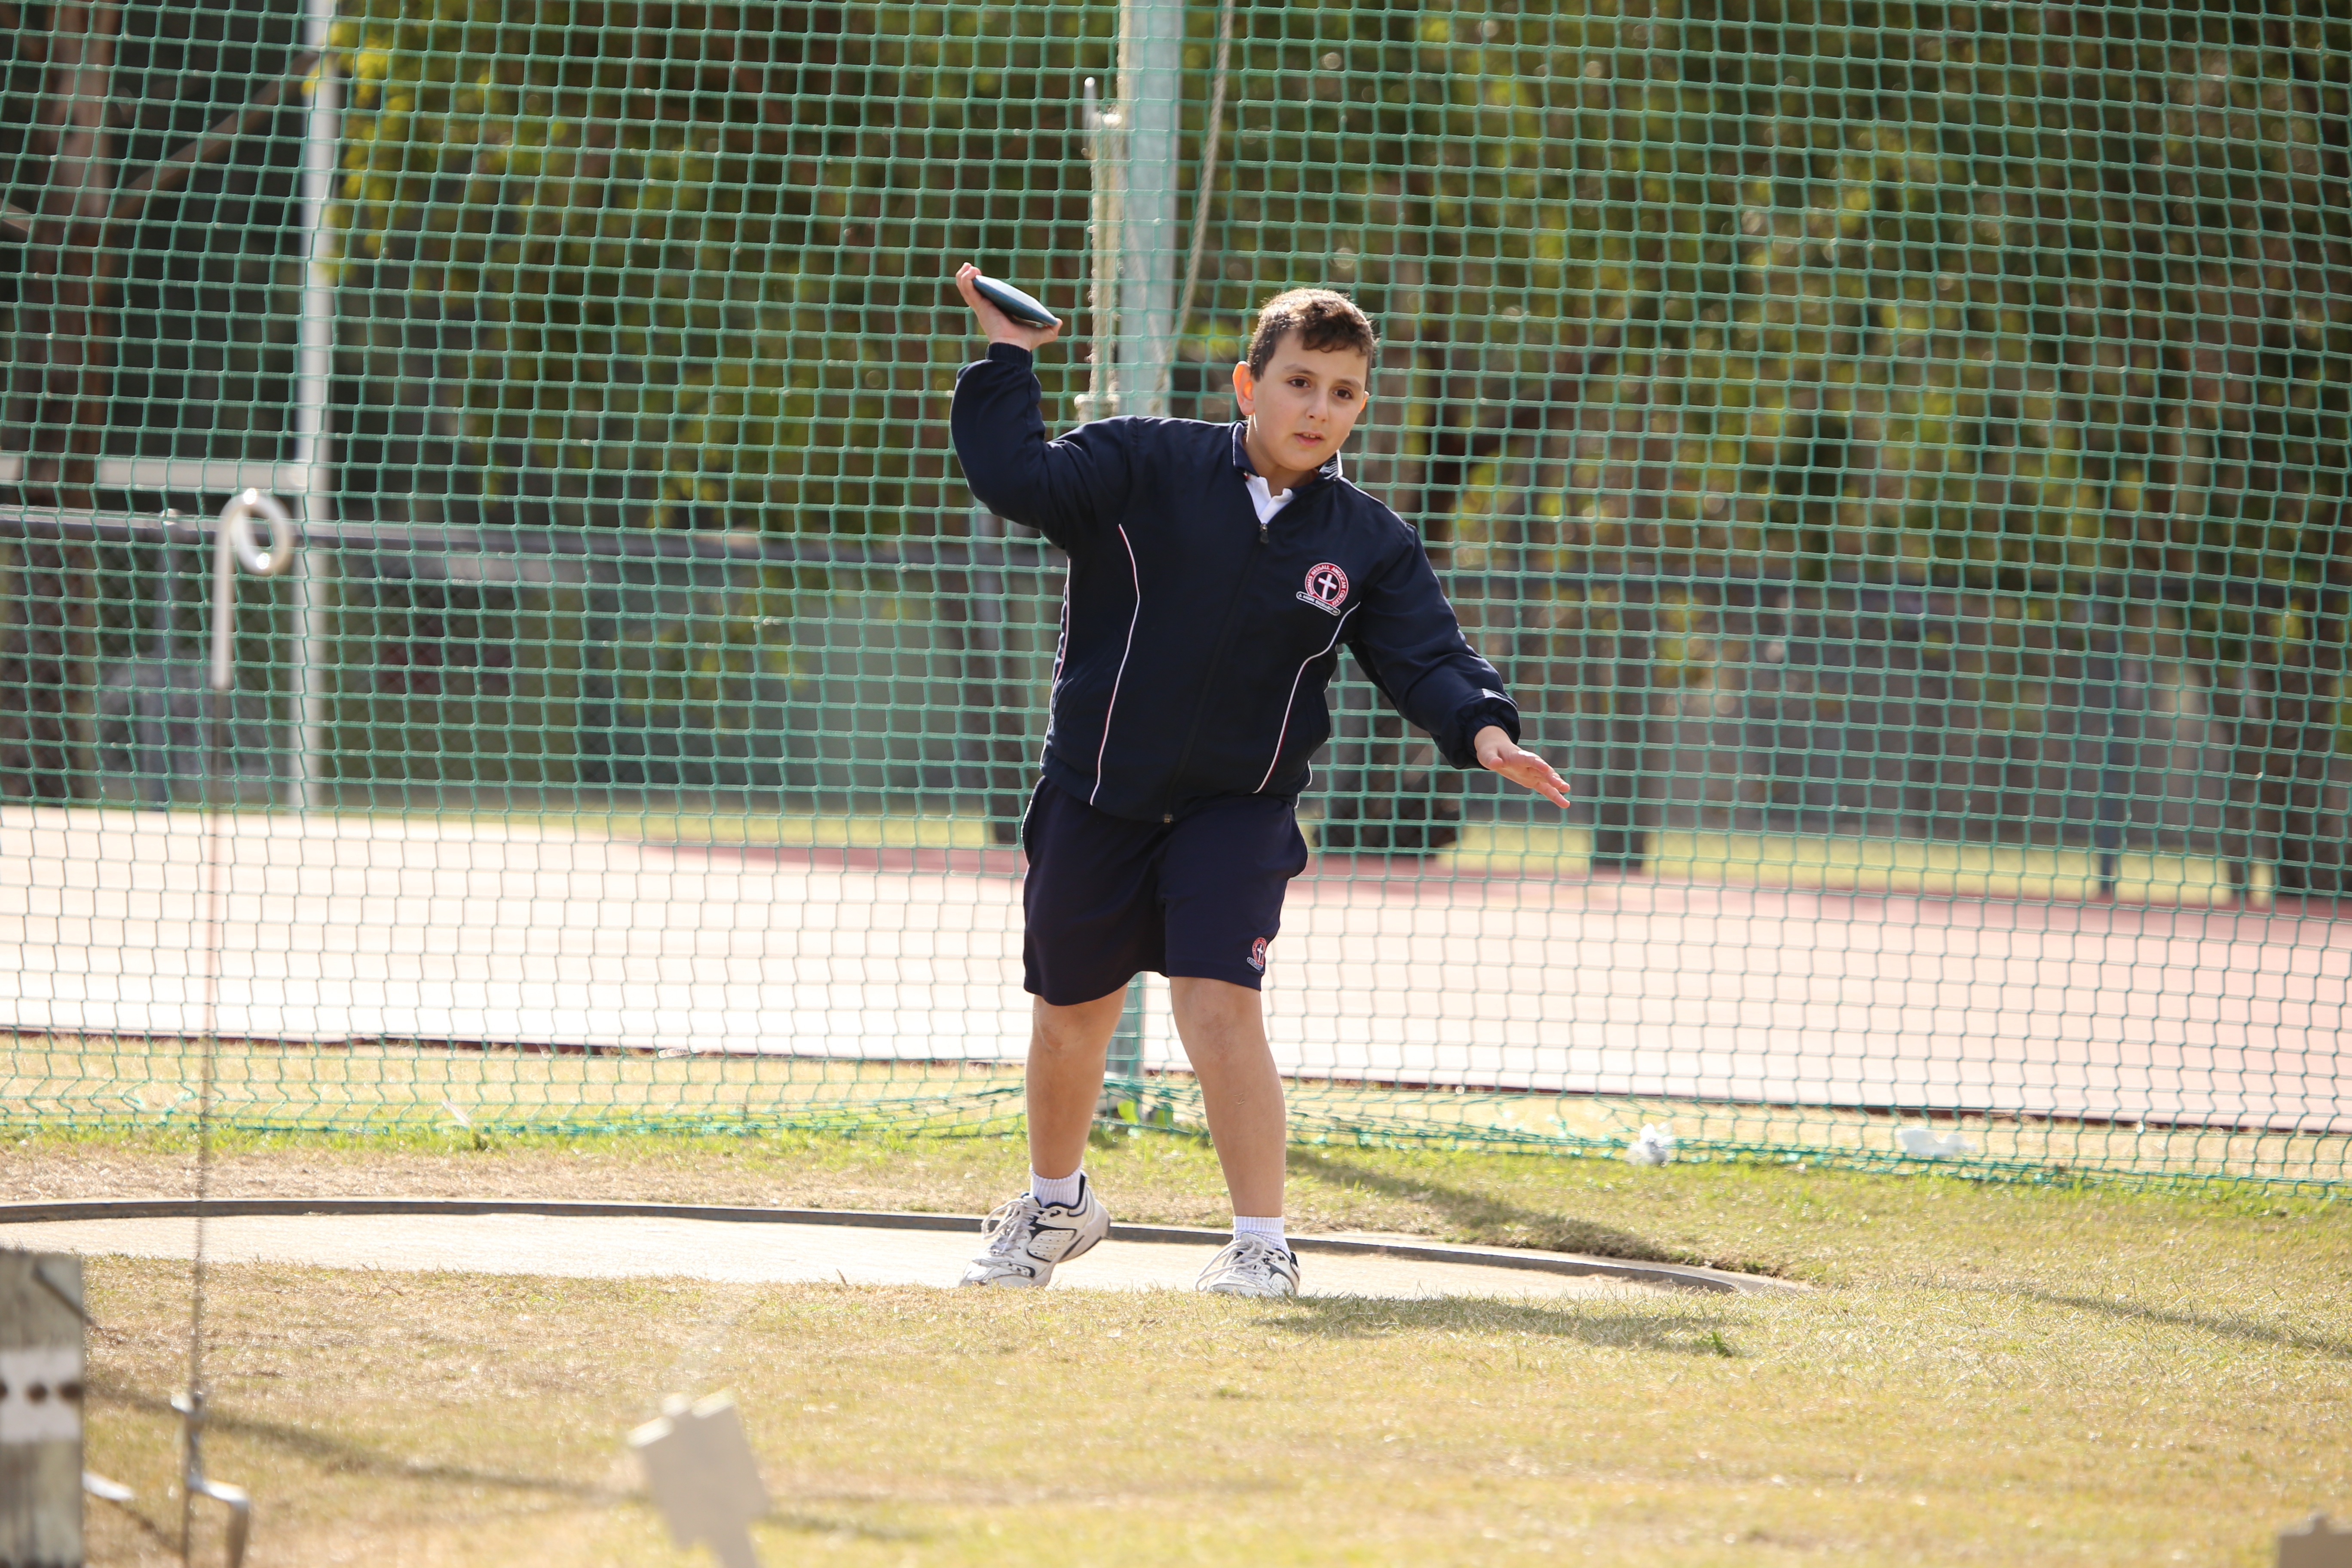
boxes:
[1194,5,2352,581]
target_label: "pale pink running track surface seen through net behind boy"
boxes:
[0,808,2352,1131]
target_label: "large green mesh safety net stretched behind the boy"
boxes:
[0,0,2352,1182]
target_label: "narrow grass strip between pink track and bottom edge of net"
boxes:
[0,1032,2352,1189]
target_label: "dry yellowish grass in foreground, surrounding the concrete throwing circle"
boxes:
[0,1138,2352,1568]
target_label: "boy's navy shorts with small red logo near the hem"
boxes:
[1021,781,1308,1006]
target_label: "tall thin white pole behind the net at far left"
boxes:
[289,15,341,811]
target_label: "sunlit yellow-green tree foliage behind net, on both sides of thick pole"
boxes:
[339,0,2352,588]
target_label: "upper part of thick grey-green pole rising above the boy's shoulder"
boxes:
[1112,0,1183,414]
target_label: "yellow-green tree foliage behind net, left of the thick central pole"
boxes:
[336,0,1110,534]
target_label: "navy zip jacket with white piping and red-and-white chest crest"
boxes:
[950,343,1519,823]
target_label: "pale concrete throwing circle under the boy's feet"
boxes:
[0,1199,1780,1300]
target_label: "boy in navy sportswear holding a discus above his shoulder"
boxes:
[950,263,1569,1295]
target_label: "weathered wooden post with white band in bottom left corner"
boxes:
[0,1251,89,1568]
